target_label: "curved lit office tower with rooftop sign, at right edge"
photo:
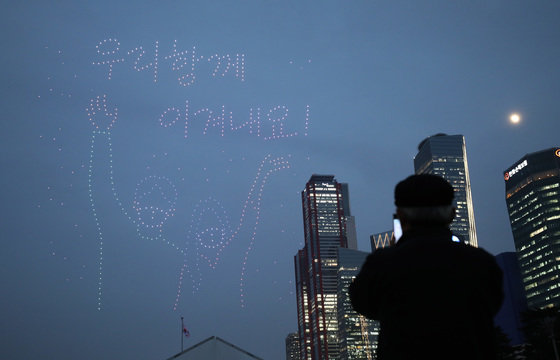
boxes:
[504,148,560,309]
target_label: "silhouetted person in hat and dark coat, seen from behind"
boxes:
[349,175,503,360]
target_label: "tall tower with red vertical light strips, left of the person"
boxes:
[294,175,355,360]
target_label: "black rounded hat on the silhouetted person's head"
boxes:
[395,174,453,207]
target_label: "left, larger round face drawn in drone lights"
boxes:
[132,176,177,233]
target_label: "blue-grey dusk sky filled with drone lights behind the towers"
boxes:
[0,0,560,360]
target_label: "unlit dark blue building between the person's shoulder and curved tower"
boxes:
[494,252,527,346]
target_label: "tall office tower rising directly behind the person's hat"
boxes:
[414,134,478,246]
